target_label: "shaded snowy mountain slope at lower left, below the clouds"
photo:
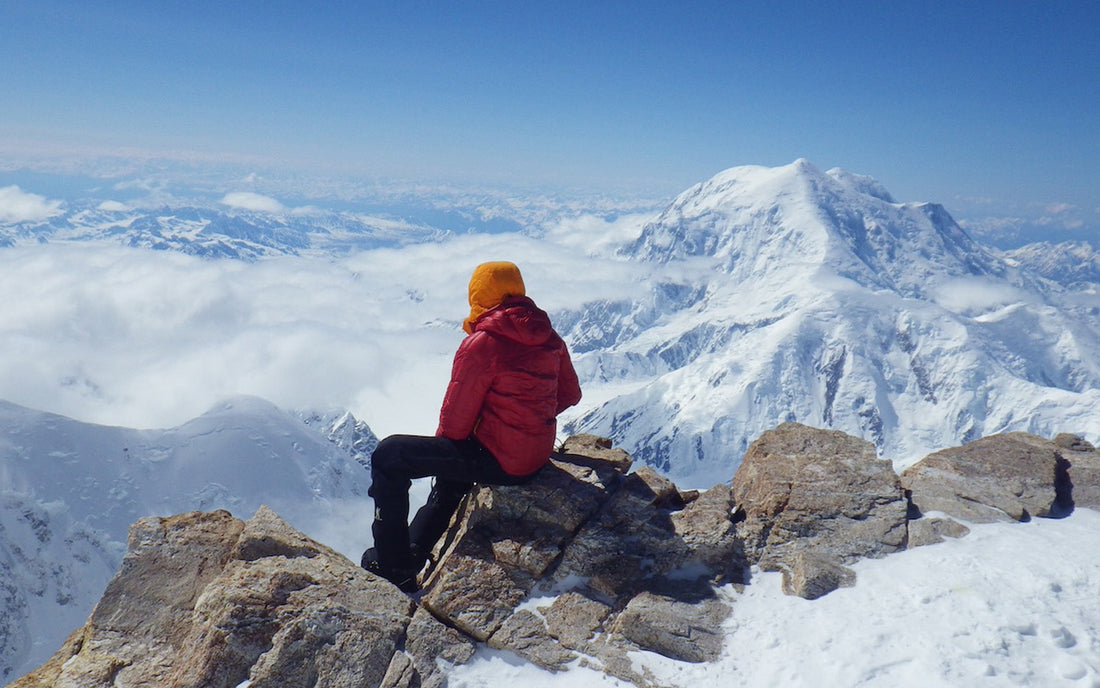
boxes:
[0,397,376,680]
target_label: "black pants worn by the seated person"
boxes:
[369,435,537,570]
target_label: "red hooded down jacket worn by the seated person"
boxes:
[436,296,581,476]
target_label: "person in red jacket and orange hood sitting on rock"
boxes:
[362,261,581,592]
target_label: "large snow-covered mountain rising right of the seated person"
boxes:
[557,160,1100,484]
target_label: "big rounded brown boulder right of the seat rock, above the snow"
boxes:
[733,423,908,599]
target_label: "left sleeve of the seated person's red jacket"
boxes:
[436,332,492,439]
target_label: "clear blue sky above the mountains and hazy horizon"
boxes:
[0,0,1100,215]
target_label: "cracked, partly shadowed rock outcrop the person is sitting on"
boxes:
[421,438,746,685]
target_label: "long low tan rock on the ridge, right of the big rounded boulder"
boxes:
[901,433,1073,523]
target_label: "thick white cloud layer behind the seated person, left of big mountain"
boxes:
[0,234,641,434]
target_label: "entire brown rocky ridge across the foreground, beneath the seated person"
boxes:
[10,423,1100,688]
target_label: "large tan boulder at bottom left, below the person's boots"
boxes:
[12,507,414,688]
